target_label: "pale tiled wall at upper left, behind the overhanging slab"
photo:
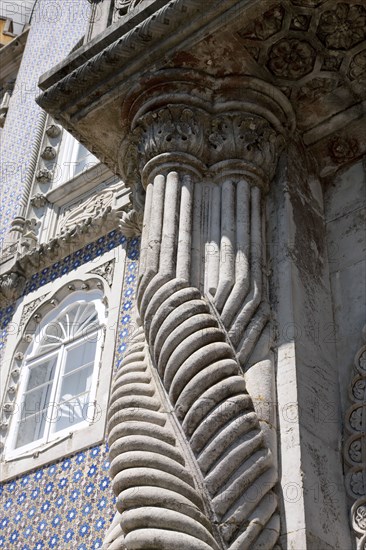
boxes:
[0,0,90,251]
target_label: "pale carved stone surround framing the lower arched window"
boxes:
[0,245,126,482]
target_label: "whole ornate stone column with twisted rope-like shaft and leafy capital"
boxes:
[109,71,293,550]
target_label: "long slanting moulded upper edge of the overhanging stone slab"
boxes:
[37,0,249,114]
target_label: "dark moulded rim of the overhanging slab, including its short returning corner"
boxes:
[37,0,255,171]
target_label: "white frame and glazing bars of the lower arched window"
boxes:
[5,291,106,459]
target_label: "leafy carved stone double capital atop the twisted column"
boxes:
[120,71,294,194]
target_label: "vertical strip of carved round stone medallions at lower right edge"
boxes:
[344,326,366,549]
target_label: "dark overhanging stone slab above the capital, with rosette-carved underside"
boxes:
[39,0,366,181]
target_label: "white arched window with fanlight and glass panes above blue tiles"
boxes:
[9,289,106,452]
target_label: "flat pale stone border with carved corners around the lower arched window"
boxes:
[0,247,125,481]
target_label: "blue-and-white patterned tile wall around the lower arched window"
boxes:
[0,235,139,550]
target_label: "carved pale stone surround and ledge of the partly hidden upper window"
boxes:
[0,117,132,296]
